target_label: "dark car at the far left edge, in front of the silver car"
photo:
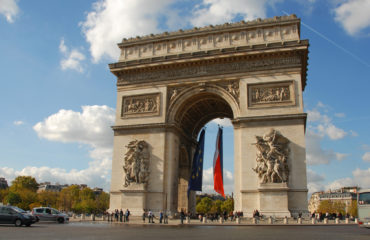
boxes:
[0,206,36,227]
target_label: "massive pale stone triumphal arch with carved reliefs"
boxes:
[109,15,308,216]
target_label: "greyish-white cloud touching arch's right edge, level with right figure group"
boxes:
[306,130,347,165]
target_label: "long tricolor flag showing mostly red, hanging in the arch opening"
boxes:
[213,127,225,197]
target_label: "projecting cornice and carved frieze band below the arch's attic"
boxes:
[109,40,309,90]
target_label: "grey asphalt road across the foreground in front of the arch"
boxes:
[0,222,370,240]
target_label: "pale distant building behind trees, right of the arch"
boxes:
[308,187,359,213]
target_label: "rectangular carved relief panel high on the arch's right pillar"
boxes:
[248,81,295,107]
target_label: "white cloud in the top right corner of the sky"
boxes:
[334,0,370,35]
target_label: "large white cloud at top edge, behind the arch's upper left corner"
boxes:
[80,0,173,62]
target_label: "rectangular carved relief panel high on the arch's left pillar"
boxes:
[122,94,160,117]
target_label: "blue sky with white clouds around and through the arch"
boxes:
[0,0,370,195]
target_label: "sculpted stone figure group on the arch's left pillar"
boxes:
[123,140,150,187]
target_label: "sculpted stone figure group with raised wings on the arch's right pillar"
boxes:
[252,129,289,183]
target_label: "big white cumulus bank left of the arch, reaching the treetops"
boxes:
[0,106,115,190]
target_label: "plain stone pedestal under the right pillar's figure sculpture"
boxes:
[258,183,291,217]
